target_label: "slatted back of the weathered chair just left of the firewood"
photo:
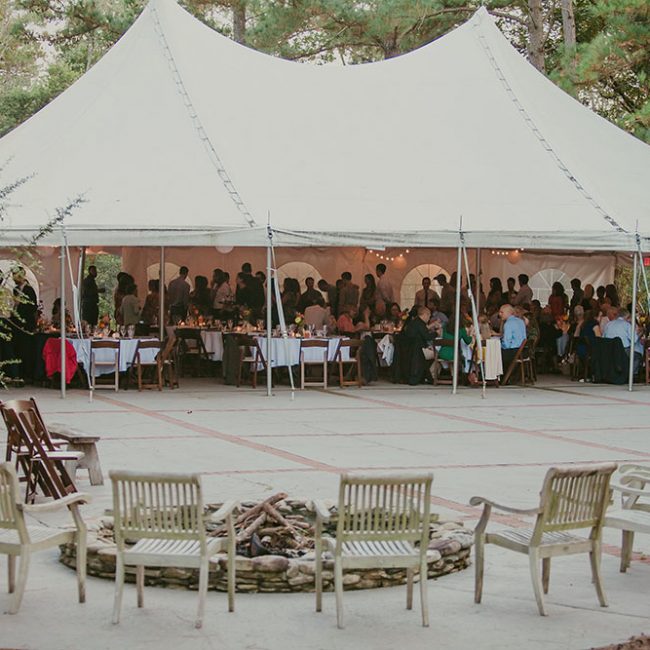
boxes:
[109,471,205,548]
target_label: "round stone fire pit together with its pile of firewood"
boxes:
[60,493,473,592]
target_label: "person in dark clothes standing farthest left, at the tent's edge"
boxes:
[11,266,38,381]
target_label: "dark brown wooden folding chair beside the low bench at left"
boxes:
[0,398,84,502]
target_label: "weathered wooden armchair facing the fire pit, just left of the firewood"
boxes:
[109,471,237,628]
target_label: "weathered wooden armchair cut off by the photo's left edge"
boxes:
[0,463,90,621]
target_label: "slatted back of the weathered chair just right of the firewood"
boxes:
[336,473,433,546]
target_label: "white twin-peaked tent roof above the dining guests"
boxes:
[0,0,650,250]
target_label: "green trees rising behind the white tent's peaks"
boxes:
[0,0,650,142]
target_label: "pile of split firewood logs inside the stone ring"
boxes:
[210,492,314,557]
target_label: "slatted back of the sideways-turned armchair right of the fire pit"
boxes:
[532,463,616,544]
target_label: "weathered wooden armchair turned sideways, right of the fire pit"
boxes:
[470,463,616,616]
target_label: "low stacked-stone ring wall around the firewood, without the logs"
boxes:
[60,504,473,593]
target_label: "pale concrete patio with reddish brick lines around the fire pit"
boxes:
[0,379,650,650]
